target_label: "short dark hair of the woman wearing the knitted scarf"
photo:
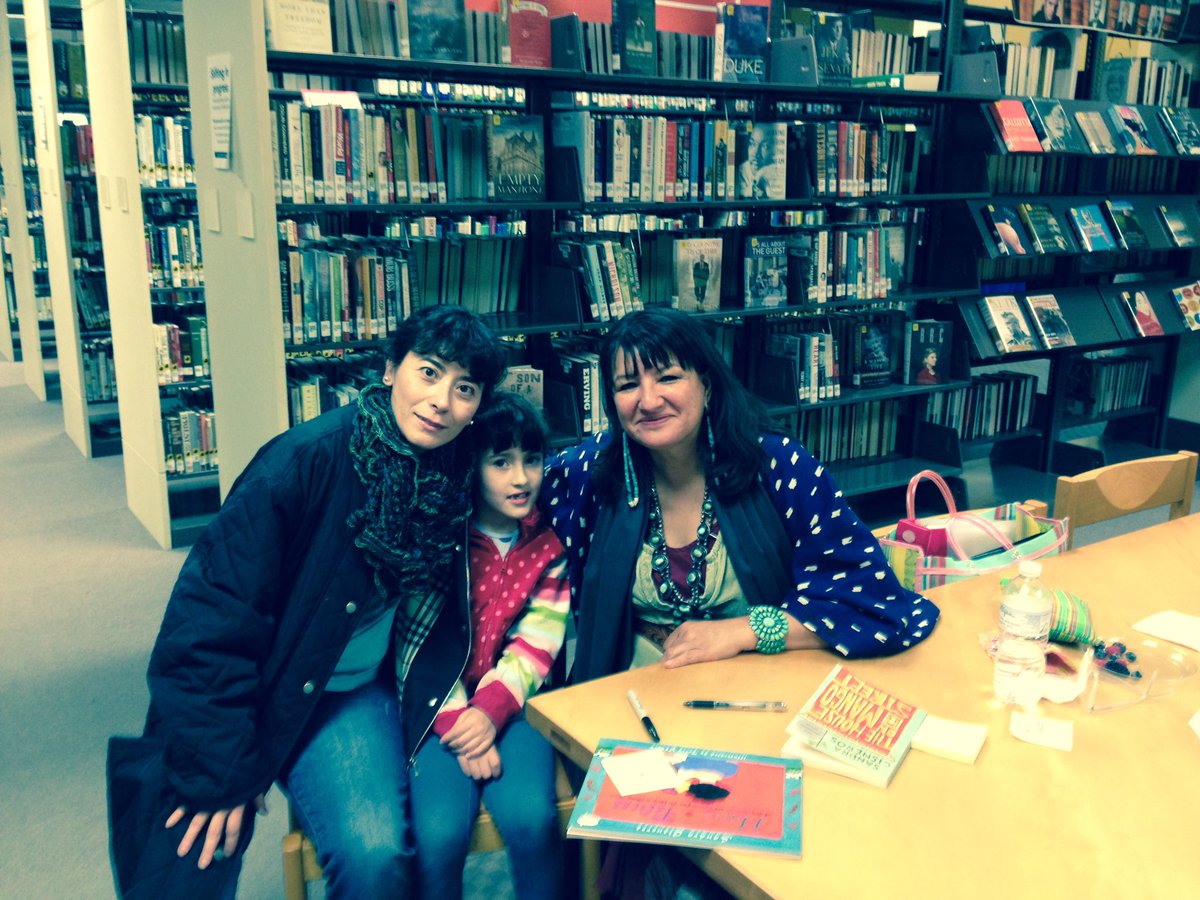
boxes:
[388,306,506,397]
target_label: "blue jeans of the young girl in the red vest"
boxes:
[409,718,563,900]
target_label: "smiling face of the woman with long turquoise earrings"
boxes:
[612,353,708,451]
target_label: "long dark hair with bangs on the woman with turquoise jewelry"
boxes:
[596,308,769,500]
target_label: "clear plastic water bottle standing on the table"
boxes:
[992,559,1054,706]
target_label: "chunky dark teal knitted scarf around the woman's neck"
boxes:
[347,384,470,601]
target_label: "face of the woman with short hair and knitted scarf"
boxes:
[384,353,484,450]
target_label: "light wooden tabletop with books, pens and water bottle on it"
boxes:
[528,515,1200,900]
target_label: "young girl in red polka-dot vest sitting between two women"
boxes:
[412,394,570,900]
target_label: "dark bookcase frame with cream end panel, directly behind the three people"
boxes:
[184,0,1017,508]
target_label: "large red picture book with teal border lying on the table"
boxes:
[566,738,804,856]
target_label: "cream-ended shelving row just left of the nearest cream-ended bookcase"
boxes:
[83,0,220,547]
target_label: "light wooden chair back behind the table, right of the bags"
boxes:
[1054,450,1196,550]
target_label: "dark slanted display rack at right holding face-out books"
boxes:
[938,14,1200,474]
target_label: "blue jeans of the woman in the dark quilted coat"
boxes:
[280,682,412,900]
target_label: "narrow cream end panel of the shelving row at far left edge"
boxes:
[0,7,47,400]
